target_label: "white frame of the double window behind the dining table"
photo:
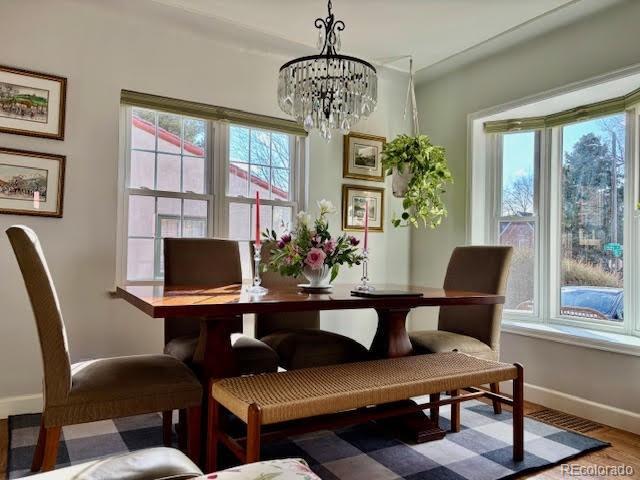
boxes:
[115,104,307,285]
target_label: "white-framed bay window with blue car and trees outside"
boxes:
[484,106,640,334]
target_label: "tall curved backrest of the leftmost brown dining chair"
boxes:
[7,225,71,405]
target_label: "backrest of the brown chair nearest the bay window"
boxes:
[438,246,513,352]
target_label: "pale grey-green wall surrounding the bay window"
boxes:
[411,1,640,416]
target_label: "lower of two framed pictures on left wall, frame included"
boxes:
[0,147,65,217]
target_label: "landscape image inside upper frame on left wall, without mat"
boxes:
[0,82,49,123]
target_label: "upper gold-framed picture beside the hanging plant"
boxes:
[342,133,387,182]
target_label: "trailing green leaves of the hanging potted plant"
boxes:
[382,135,453,228]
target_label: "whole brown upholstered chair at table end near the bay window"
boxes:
[409,246,513,413]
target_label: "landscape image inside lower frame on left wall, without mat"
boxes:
[0,163,49,202]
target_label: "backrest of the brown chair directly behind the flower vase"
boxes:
[250,242,320,338]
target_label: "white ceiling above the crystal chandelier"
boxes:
[144,0,616,70]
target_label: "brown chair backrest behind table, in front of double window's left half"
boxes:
[164,238,242,343]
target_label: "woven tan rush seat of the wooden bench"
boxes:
[212,352,517,425]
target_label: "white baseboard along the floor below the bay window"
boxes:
[501,382,640,435]
